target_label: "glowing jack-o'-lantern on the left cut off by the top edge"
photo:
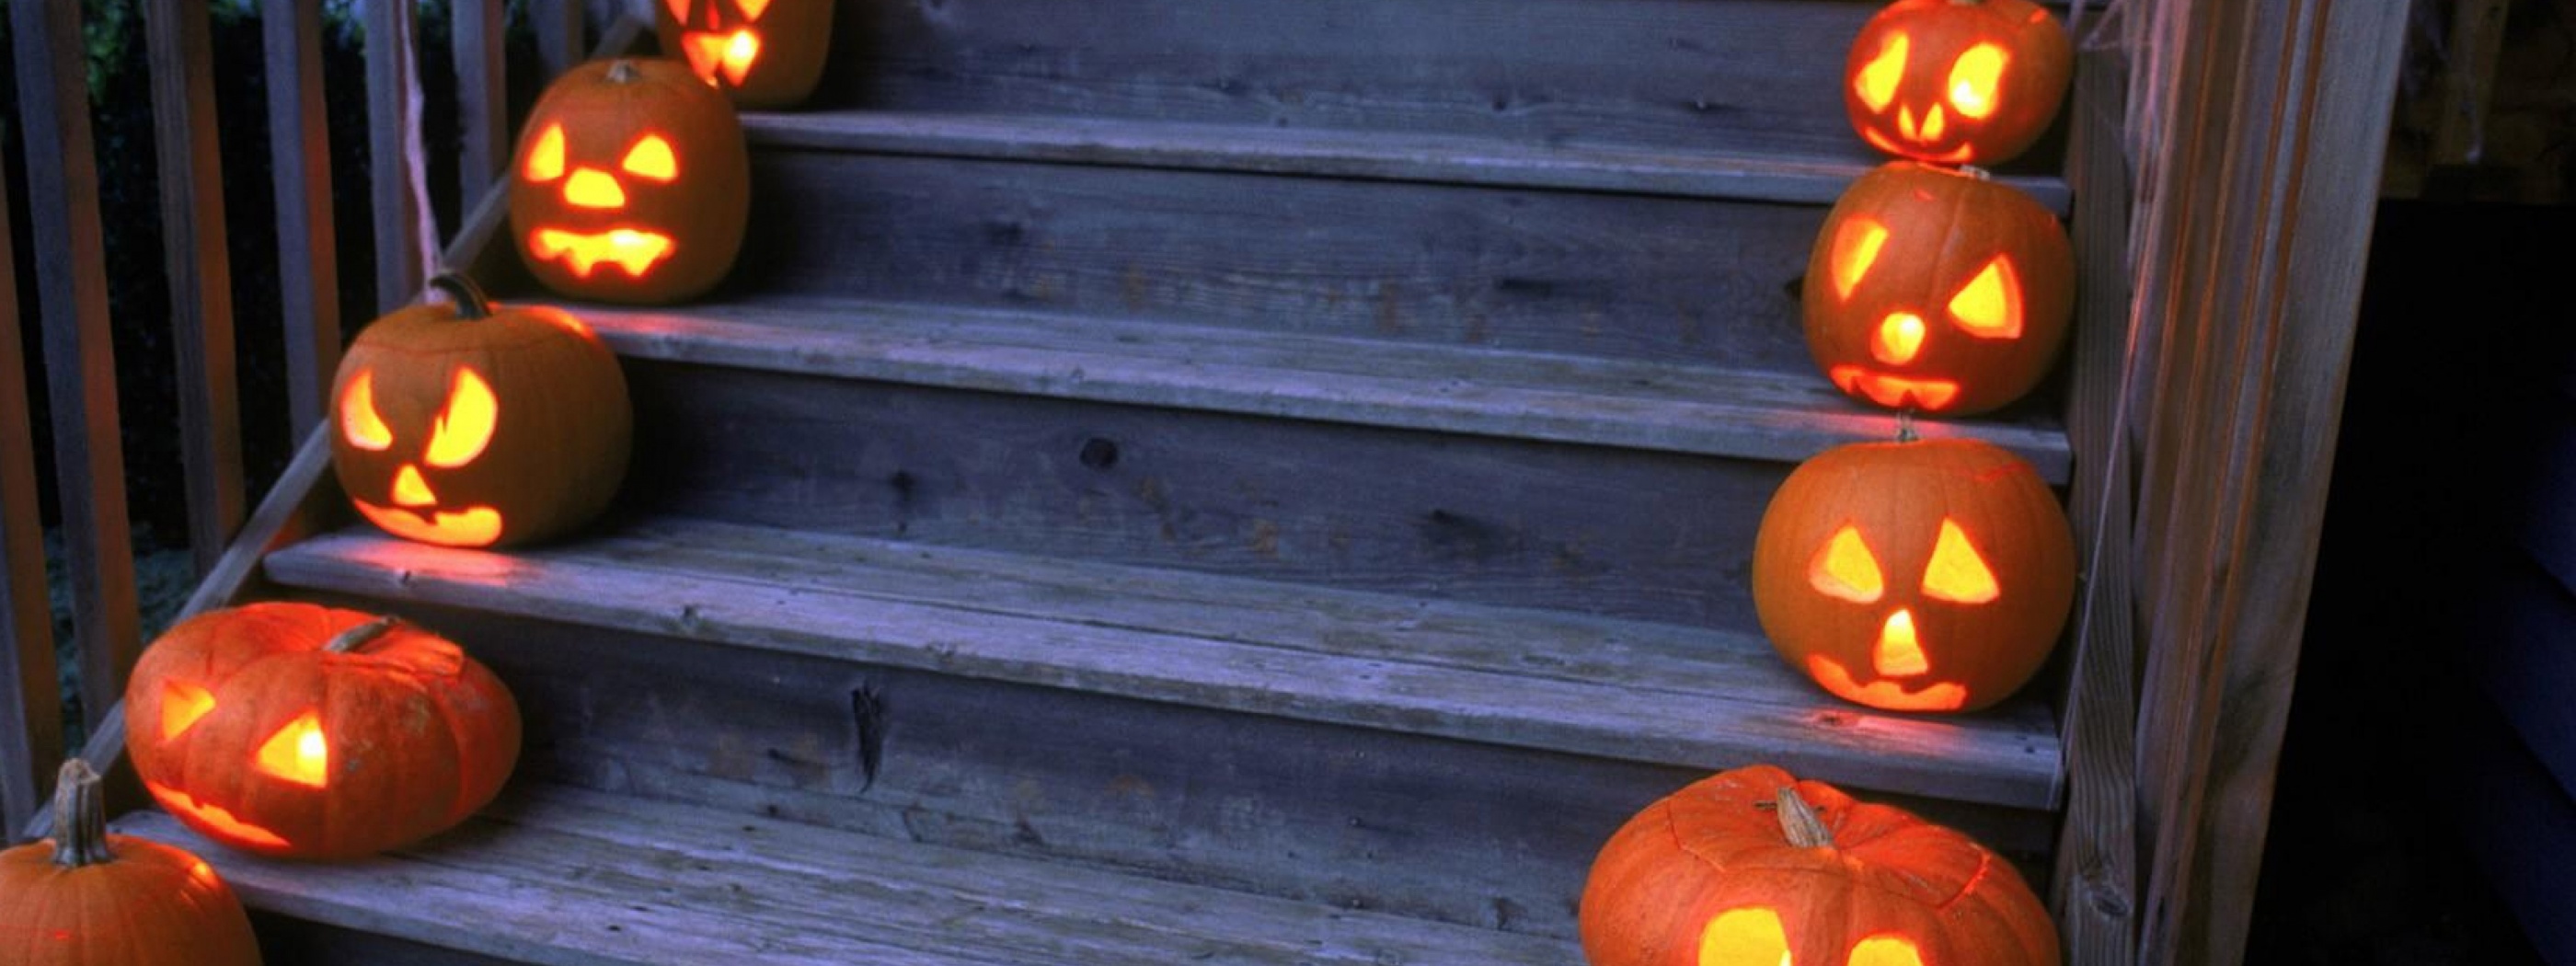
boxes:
[654,0,834,109]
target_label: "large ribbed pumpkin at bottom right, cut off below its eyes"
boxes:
[1581,765,2058,966]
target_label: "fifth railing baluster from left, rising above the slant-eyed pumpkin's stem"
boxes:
[366,0,428,315]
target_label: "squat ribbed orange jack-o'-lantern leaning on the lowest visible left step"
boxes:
[126,603,521,857]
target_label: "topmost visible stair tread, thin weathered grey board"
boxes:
[742,110,2066,212]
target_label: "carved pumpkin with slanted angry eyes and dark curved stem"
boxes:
[329,276,634,546]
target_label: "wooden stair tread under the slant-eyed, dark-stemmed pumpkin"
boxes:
[268,521,2064,809]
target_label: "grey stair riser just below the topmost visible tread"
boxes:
[727,149,1823,374]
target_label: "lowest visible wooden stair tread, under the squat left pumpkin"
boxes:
[116,786,1581,966]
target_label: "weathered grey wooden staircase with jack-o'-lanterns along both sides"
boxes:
[119,0,2071,966]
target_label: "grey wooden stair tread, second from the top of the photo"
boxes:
[569,302,2068,482]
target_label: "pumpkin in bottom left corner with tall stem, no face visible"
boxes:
[0,757,260,966]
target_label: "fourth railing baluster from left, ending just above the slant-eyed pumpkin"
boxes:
[260,0,340,435]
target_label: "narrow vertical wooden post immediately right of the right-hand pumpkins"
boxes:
[2051,54,2138,966]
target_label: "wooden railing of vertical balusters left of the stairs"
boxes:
[0,0,585,834]
